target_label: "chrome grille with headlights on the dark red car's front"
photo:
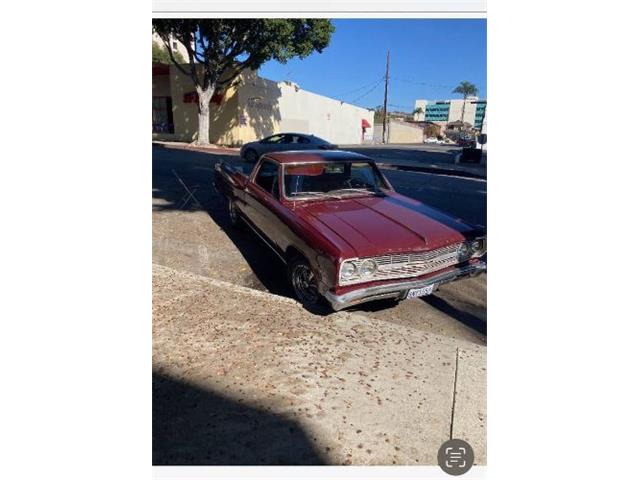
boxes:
[340,243,460,285]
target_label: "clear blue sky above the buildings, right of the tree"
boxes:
[259,19,487,111]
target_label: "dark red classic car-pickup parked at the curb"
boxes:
[214,150,486,310]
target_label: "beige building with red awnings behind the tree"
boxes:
[153,64,373,146]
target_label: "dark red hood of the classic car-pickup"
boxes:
[294,192,473,258]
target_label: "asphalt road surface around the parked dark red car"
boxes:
[152,146,486,344]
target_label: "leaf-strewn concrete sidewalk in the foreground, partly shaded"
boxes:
[153,265,486,465]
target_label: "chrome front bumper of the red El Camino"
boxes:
[324,261,487,311]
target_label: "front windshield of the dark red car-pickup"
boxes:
[284,161,386,198]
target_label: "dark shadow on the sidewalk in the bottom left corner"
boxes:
[153,373,325,465]
